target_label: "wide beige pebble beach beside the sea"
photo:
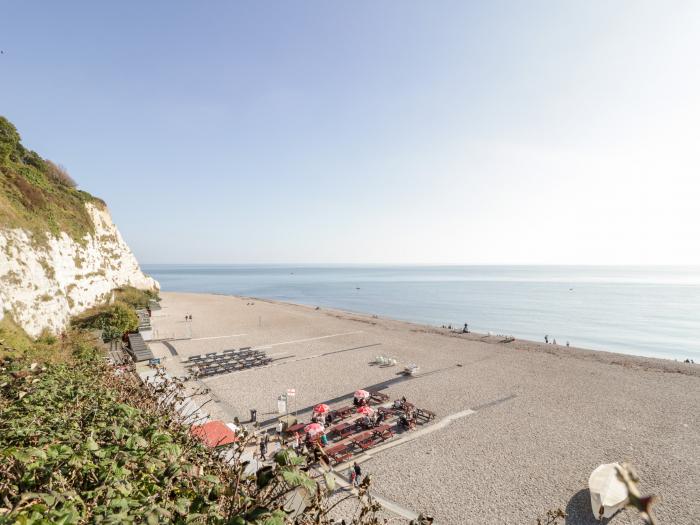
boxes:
[150,292,700,525]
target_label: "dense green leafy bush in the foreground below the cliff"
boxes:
[0,338,378,525]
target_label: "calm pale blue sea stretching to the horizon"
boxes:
[144,265,700,362]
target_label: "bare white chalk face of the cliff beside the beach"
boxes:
[0,202,158,336]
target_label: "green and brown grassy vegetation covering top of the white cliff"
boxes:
[0,116,104,245]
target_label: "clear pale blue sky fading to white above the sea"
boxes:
[0,0,700,264]
